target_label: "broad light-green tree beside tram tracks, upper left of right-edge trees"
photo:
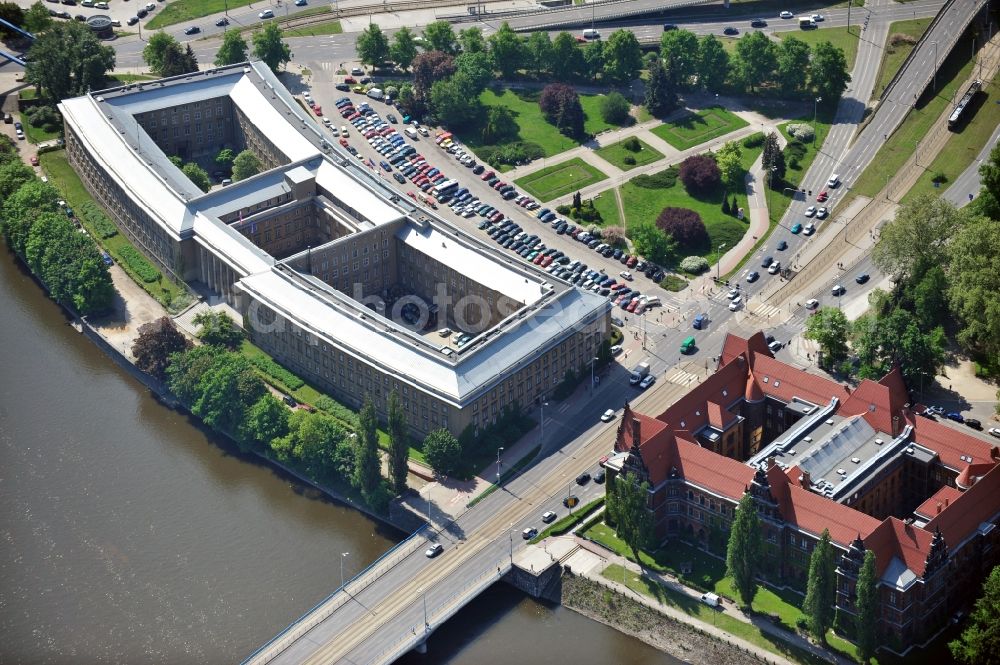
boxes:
[872,194,960,282]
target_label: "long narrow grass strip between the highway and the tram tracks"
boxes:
[838,39,981,202]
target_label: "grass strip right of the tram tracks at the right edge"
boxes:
[903,68,1000,202]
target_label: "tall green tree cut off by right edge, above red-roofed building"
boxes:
[947,213,1000,357]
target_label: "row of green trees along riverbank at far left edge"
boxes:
[0,137,115,315]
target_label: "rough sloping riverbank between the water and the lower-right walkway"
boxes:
[562,573,761,665]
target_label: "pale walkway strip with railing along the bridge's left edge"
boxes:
[241,524,427,665]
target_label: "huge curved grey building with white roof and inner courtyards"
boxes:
[60,62,610,433]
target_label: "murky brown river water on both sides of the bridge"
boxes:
[0,248,678,665]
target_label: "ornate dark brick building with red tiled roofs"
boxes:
[606,333,1000,653]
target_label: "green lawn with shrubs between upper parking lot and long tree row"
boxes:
[458,89,614,163]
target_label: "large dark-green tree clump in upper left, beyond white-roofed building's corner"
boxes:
[25,21,115,103]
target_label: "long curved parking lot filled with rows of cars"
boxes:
[302,86,677,311]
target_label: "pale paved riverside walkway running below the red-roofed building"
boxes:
[553,535,853,665]
